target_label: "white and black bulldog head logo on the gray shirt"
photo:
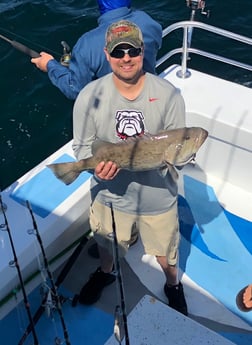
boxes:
[116,110,144,139]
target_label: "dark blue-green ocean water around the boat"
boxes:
[0,0,252,189]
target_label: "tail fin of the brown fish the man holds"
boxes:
[47,162,80,185]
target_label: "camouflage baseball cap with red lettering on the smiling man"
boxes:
[105,20,143,53]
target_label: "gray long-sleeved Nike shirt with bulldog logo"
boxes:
[73,73,185,215]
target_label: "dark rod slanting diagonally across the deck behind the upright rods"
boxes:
[18,231,88,345]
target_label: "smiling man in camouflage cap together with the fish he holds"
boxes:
[49,20,207,315]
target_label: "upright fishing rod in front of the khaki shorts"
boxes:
[109,203,130,345]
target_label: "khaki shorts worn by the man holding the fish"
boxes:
[90,201,180,265]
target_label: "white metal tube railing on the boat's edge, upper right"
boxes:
[156,20,252,78]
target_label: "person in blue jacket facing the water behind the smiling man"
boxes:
[31,0,162,100]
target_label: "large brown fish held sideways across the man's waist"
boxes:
[47,127,208,185]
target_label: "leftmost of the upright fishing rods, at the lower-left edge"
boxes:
[0,195,39,345]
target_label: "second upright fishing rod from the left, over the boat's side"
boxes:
[26,201,71,345]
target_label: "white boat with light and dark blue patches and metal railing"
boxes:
[0,1,252,345]
